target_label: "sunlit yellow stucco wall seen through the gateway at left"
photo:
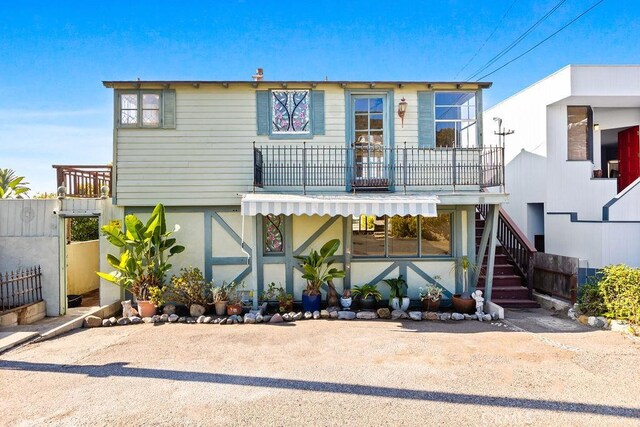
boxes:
[67,240,100,295]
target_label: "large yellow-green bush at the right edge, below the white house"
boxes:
[598,264,640,324]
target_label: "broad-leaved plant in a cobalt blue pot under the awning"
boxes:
[295,239,344,312]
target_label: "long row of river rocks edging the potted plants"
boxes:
[84,307,498,328]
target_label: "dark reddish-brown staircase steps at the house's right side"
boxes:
[476,212,539,308]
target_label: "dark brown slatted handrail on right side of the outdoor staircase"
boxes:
[478,205,538,298]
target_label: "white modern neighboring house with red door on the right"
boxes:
[484,65,640,280]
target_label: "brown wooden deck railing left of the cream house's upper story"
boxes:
[53,165,111,198]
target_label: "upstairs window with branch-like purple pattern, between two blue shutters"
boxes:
[271,90,310,134]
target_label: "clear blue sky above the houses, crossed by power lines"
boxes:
[0,0,640,191]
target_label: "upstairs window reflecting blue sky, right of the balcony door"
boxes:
[435,92,477,147]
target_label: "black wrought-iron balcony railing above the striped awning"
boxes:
[253,143,504,194]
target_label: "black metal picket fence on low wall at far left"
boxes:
[0,266,42,314]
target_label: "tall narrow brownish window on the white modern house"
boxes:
[567,106,593,160]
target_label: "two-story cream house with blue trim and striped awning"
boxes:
[104,74,526,308]
